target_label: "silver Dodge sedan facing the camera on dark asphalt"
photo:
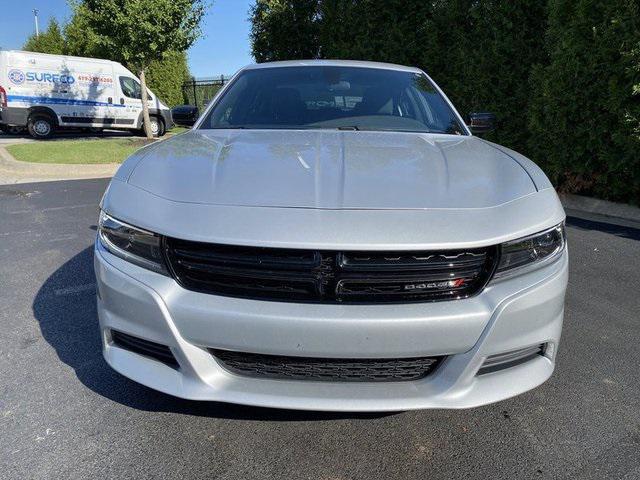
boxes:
[95,60,568,411]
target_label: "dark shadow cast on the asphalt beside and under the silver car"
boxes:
[33,247,390,421]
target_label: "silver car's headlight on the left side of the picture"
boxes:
[98,211,168,275]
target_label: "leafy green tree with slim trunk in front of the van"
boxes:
[83,0,206,138]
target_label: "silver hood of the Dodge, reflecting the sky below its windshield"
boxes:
[125,130,536,210]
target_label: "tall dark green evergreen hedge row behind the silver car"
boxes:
[251,0,640,204]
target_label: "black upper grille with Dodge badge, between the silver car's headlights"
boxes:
[164,238,496,303]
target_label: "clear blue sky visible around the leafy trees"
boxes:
[0,0,253,77]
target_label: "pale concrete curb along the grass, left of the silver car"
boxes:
[0,147,120,183]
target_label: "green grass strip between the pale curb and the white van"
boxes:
[6,138,155,165]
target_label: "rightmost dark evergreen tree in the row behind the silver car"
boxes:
[530,0,640,203]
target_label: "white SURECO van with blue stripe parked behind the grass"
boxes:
[0,50,173,138]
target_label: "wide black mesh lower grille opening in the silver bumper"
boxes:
[211,350,442,382]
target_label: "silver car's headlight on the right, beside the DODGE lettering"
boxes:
[494,223,565,278]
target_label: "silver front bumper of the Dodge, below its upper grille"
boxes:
[95,243,568,411]
